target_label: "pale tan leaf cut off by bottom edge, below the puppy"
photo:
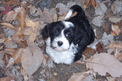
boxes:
[68,70,91,81]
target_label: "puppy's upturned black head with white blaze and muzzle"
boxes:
[43,21,74,51]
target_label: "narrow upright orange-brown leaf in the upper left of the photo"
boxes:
[17,8,26,30]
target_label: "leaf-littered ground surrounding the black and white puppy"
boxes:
[0,0,122,81]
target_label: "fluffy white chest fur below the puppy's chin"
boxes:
[46,38,77,64]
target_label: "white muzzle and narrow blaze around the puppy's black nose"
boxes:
[52,30,69,51]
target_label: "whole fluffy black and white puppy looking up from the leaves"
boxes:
[43,5,95,64]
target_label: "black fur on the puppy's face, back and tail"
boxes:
[43,5,95,62]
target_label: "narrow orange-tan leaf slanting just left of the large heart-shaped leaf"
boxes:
[6,48,24,68]
